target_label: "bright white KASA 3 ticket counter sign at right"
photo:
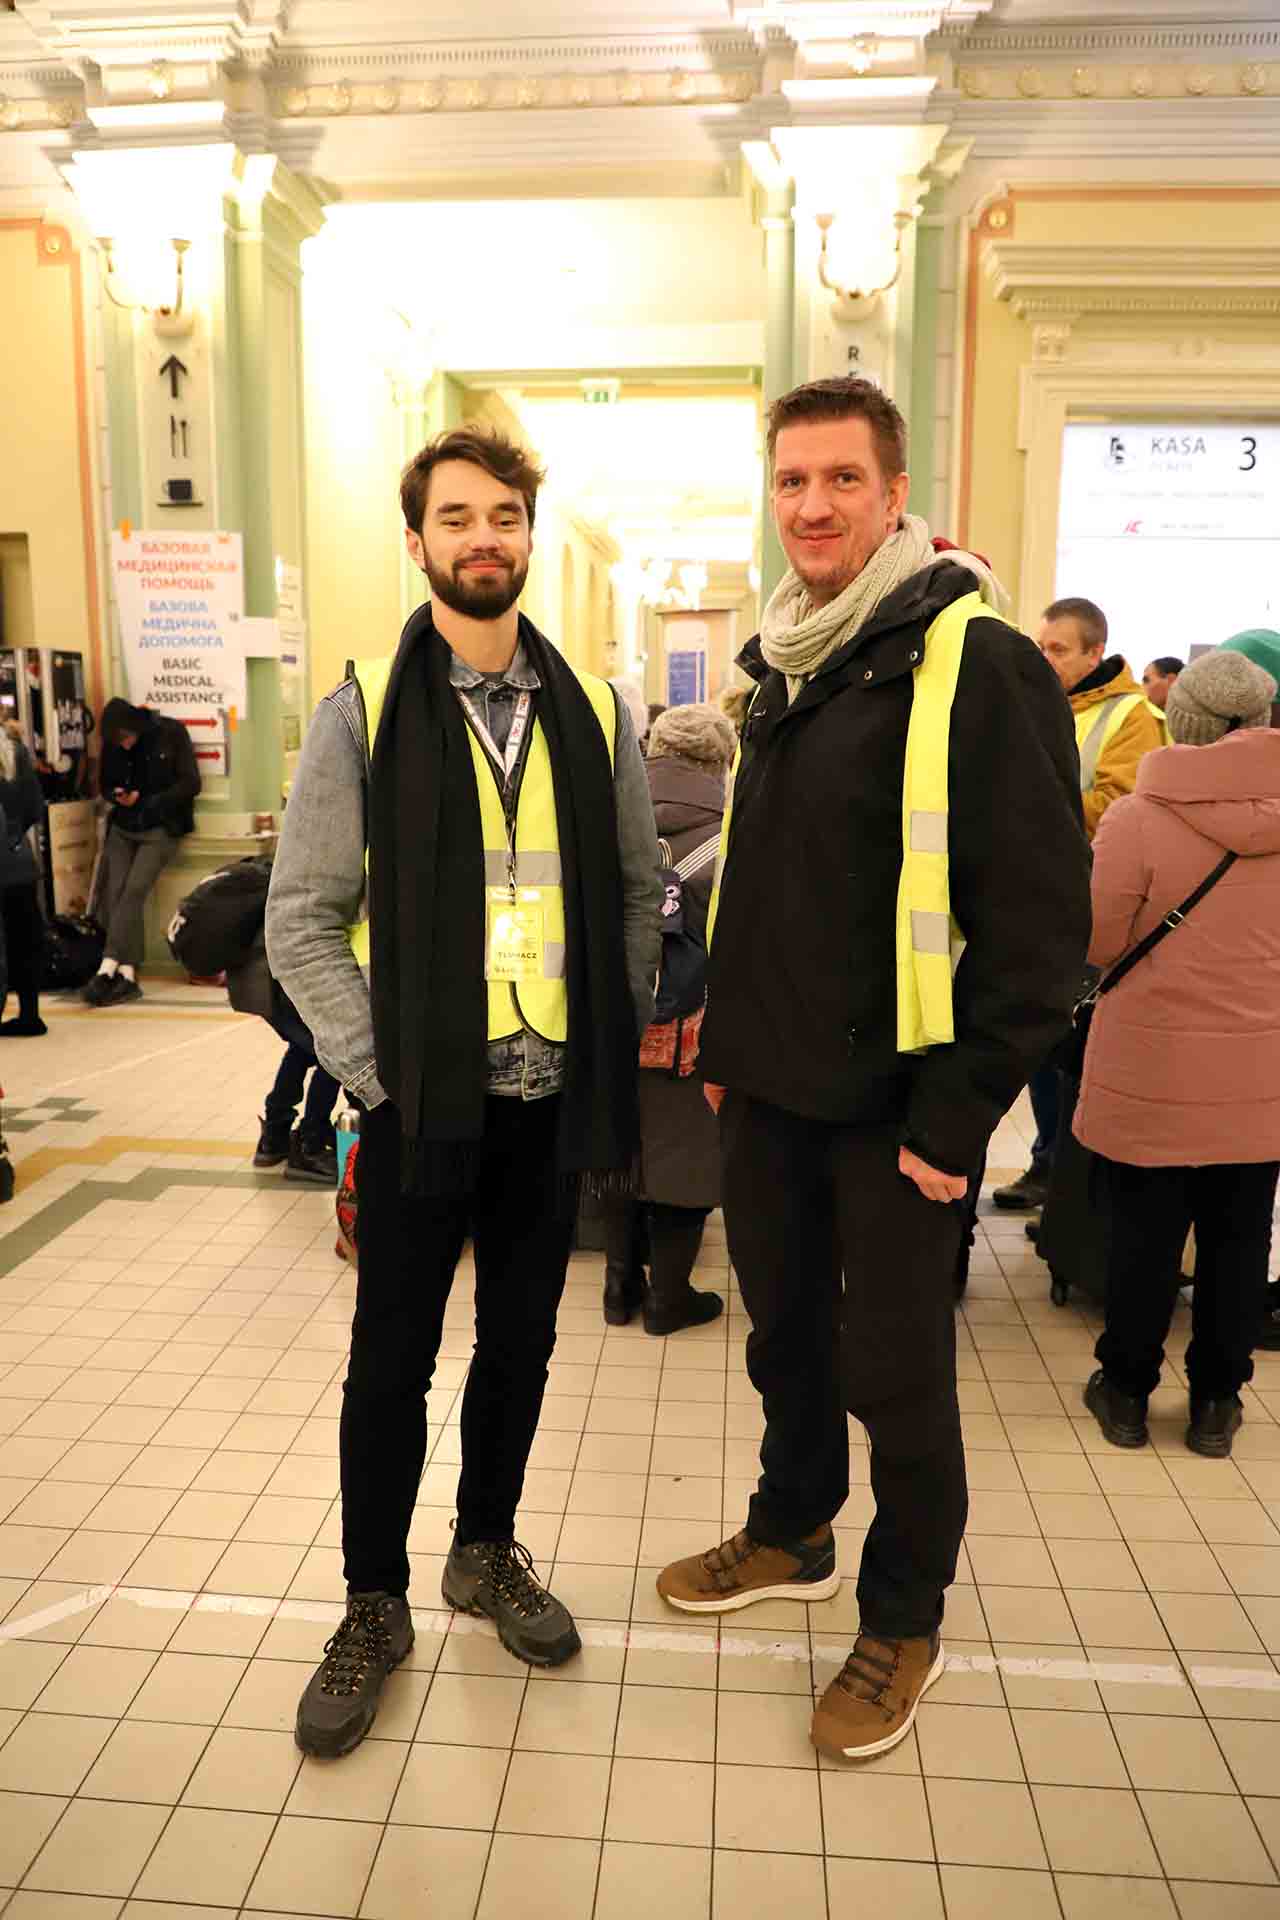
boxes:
[1054,420,1280,674]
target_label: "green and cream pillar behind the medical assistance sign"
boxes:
[94,148,324,970]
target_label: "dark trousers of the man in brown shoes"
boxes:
[720,1092,969,1638]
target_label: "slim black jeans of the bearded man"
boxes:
[340,1096,574,1594]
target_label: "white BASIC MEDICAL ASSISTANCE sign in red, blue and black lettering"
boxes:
[111,528,246,720]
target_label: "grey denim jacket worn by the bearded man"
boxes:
[267,641,662,1106]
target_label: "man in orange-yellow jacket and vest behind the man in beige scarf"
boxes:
[992,599,1169,1213]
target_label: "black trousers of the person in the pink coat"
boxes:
[1096,1158,1280,1405]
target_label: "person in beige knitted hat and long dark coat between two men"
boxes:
[604,705,737,1334]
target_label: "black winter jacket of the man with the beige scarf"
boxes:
[700,561,1090,1175]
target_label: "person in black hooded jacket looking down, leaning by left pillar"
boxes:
[83,699,200,1006]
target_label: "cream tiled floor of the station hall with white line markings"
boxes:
[0,991,1280,1920]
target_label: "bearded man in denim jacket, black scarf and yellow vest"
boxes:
[267,426,662,1757]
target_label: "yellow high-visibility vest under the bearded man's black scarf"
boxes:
[347,659,618,1044]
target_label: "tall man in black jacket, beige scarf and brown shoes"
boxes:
[658,366,1090,1759]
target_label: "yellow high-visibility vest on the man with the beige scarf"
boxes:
[706,591,1000,1054]
